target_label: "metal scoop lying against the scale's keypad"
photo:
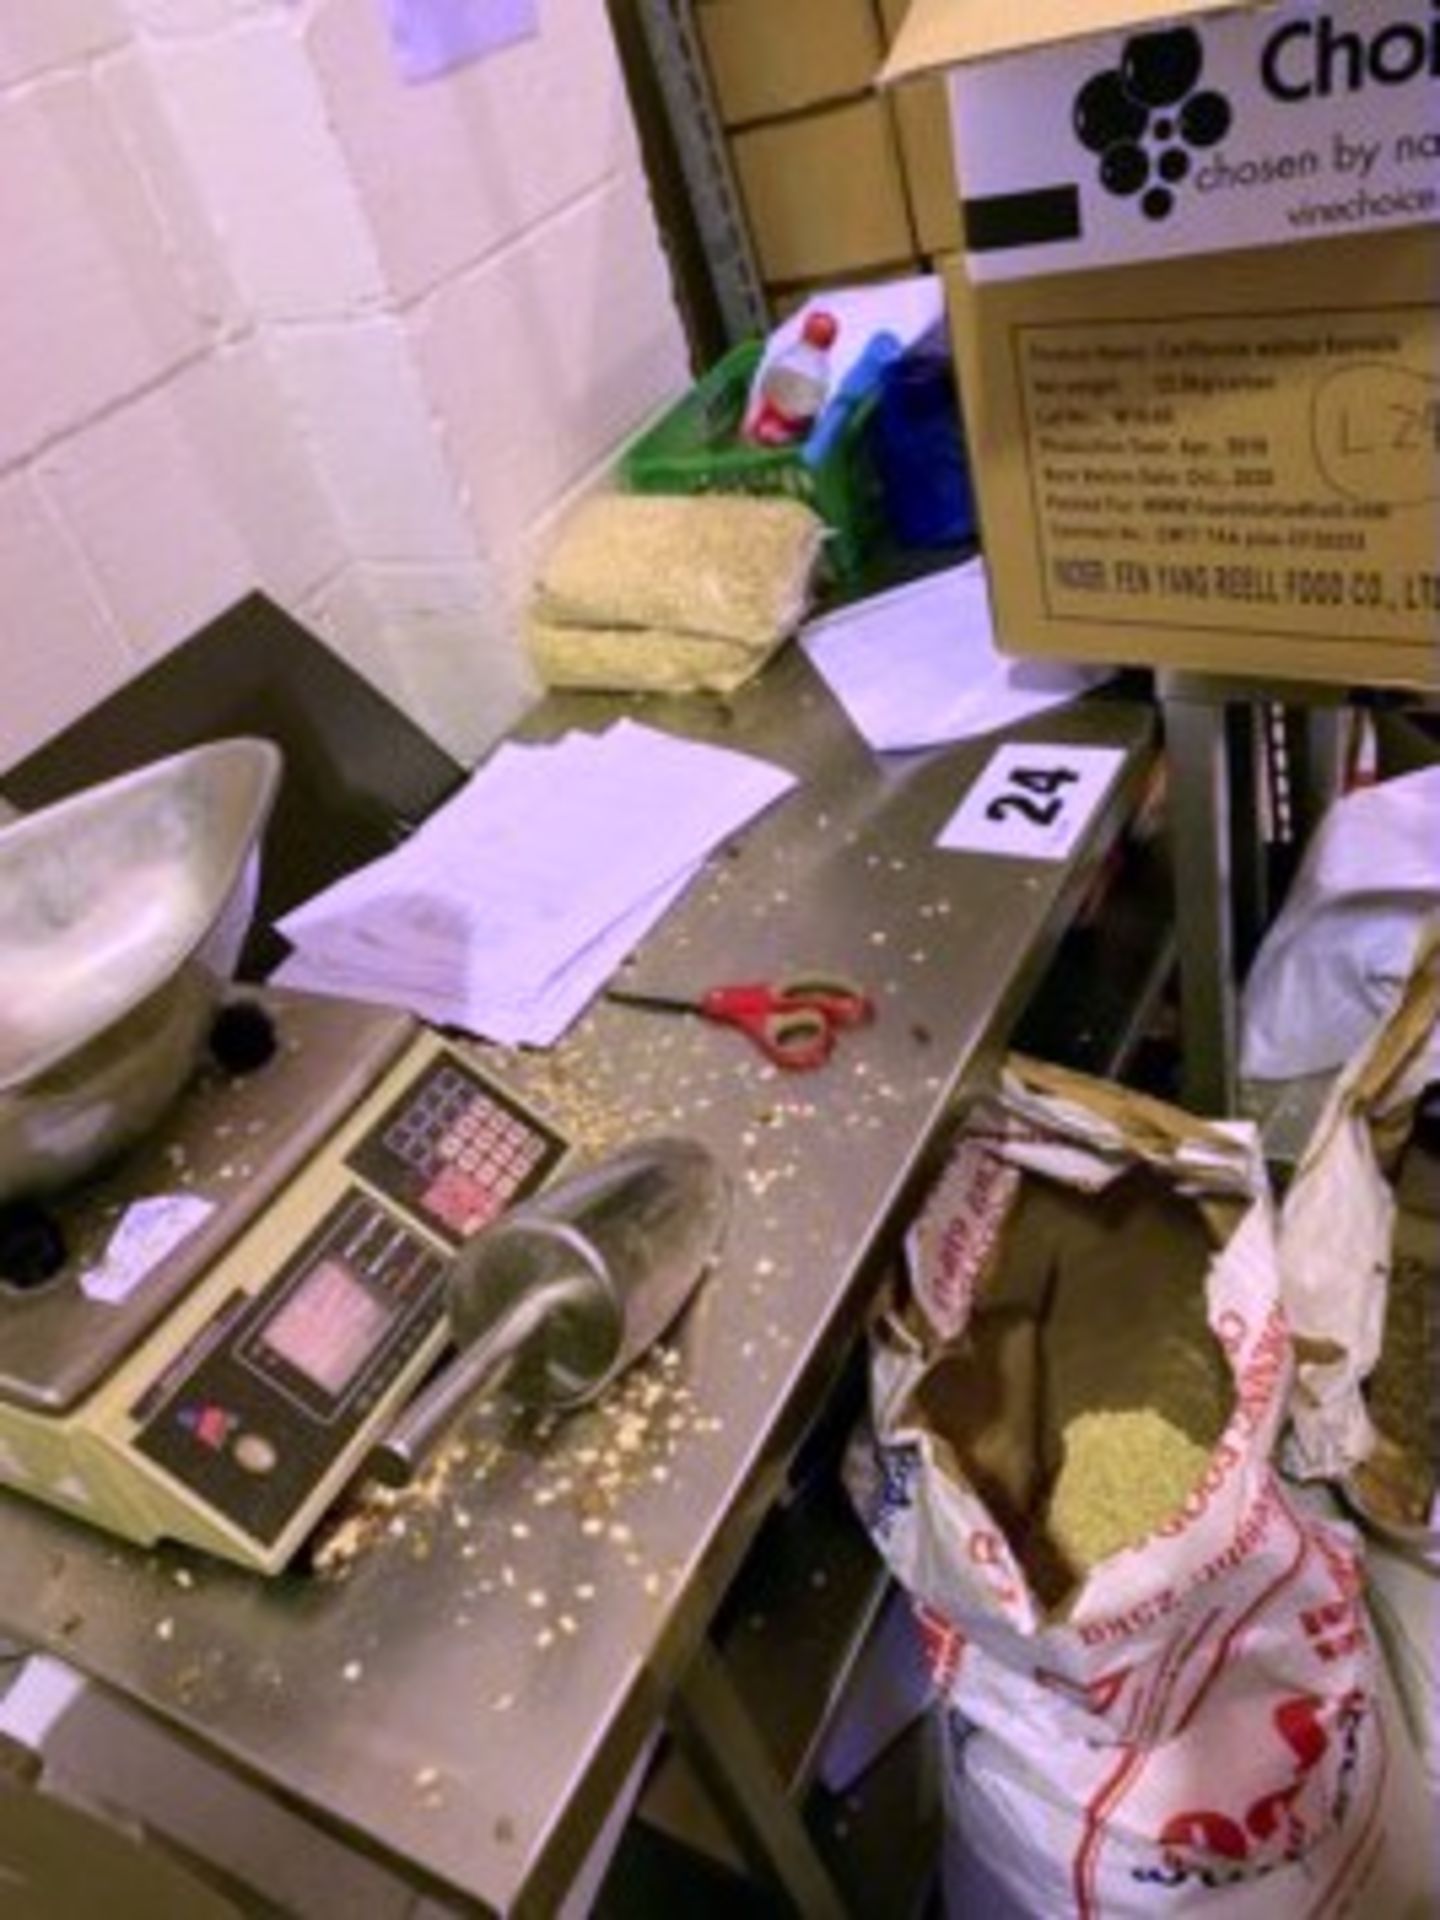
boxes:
[369,1137,730,1486]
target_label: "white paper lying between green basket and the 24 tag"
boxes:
[803,561,1110,753]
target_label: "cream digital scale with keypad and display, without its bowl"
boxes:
[0,993,566,1572]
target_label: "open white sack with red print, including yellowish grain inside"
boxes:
[847,1058,1386,1920]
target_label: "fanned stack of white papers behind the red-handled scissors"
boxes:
[275,720,795,1046]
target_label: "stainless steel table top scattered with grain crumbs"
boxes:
[0,649,1154,1912]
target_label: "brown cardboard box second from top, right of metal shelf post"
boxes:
[730,98,914,284]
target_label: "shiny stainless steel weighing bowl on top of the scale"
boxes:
[0,739,280,1200]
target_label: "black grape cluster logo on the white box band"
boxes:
[1075,27,1233,221]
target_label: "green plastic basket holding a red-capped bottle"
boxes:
[620,340,883,580]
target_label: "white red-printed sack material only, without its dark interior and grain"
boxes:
[847,1060,1384,1920]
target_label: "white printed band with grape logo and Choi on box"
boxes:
[950,0,1440,280]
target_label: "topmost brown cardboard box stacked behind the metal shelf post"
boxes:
[695,0,881,127]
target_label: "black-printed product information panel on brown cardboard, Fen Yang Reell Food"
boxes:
[1012,305,1440,647]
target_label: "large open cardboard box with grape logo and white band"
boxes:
[885,0,1440,689]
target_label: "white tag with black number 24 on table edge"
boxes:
[937,741,1125,860]
